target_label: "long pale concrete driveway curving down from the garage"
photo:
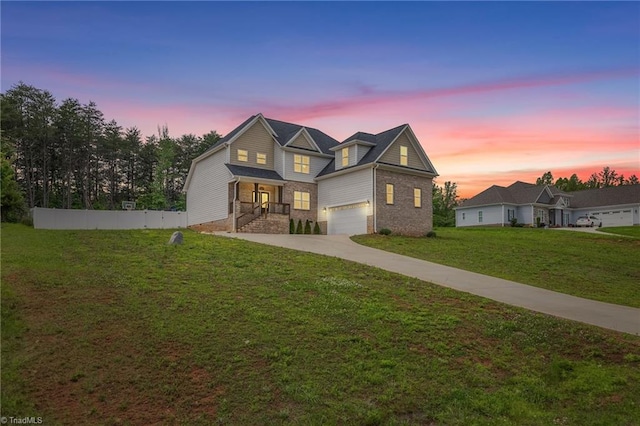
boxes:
[215,232,640,335]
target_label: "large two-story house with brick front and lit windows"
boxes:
[184,114,437,235]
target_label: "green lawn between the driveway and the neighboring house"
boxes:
[352,227,640,307]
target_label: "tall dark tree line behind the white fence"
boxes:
[0,82,220,220]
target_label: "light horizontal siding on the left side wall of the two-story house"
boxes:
[187,149,232,226]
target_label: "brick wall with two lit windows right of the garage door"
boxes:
[376,169,433,236]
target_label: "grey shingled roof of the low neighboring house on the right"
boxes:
[460,181,640,209]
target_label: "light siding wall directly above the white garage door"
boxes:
[318,168,373,221]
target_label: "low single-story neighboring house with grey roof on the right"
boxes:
[456,181,640,227]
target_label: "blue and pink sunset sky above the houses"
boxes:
[0,1,640,197]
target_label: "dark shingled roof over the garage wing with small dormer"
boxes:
[318,124,436,177]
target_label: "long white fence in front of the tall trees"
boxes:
[32,207,187,229]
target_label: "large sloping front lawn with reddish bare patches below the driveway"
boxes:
[1,225,640,425]
